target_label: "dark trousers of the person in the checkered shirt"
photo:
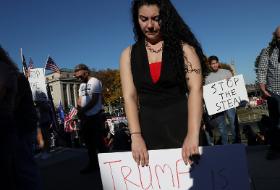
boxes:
[267,93,280,147]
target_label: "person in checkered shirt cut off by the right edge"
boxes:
[257,26,280,160]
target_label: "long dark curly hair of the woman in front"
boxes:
[131,0,206,86]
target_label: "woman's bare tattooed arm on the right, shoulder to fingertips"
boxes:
[182,44,203,164]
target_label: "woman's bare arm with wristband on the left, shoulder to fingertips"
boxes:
[120,47,149,166]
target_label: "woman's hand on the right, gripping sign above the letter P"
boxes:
[182,135,200,165]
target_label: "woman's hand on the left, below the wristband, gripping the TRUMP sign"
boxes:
[131,134,149,167]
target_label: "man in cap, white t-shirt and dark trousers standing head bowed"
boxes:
[74,64,106,174]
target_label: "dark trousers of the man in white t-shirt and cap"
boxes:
[81,113,107,167]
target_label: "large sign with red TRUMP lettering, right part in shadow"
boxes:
[98,144,250,190]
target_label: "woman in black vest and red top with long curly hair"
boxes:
[120,0,205,166]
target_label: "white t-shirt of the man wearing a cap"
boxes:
[79,77,102,116]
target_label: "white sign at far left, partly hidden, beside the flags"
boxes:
[28,68,48,101]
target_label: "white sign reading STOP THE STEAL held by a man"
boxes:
[203,75,249,115]
